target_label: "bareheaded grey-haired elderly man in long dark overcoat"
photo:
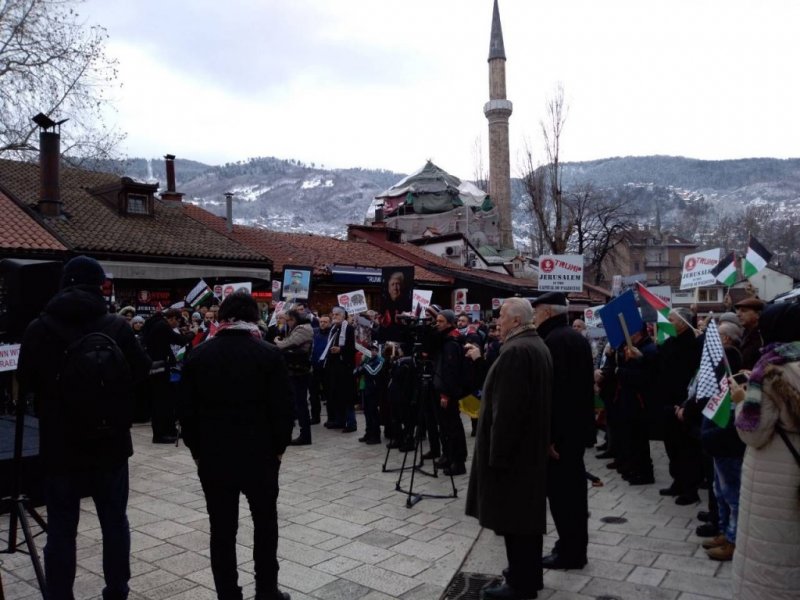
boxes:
[466,298,553,599]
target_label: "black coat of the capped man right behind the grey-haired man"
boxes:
[537,315,597,456]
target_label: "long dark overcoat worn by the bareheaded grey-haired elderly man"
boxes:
[466,329,553,535]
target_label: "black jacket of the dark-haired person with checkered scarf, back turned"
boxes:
[178,329,293,461]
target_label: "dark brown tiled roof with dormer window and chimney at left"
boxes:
[0,160,265,262]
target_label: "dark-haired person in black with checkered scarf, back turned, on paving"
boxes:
[178,292,293,600]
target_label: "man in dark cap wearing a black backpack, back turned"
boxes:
[17,256,150,600]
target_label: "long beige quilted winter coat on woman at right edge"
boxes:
[732,362,800,600]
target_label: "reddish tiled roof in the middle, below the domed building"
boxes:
[186,205,452,284]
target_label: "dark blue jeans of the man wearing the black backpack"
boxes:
[44,461,131,600]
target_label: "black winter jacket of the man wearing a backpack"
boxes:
[17,285,150,473]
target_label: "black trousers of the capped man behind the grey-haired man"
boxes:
[547,448,589,562]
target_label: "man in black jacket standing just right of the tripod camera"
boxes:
[433,310,468,475]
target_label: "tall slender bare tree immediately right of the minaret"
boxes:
[522,85,574,254]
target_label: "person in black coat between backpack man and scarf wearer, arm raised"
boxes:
[142,308,194,444]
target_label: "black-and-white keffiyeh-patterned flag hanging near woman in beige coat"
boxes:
[696,319,733,428]
